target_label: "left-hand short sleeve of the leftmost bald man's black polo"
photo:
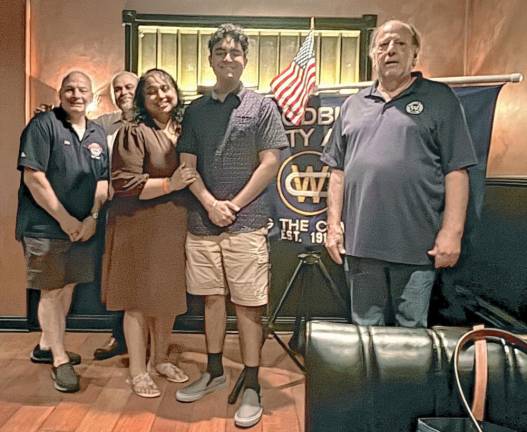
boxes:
[18,113,53,172]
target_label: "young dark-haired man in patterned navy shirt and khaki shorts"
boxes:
[176,24,288,427]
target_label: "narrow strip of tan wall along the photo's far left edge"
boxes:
[0,0,26,316]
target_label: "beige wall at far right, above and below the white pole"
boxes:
[467,0,527,178]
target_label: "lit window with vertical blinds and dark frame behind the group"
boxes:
[123,11,376,99]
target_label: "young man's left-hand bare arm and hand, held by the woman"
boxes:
[180,153,240,226]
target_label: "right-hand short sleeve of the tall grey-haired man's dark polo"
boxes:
[436,88,478,175]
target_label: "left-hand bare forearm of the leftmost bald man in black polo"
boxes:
[24,167,82,241]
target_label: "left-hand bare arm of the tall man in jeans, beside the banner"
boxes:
[326,169,346,264]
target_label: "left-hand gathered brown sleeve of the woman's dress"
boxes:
[111,125,148,196]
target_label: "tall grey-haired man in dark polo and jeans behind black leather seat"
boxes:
[322,21,477,327]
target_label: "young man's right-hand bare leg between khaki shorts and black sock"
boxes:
[236,305,264,367]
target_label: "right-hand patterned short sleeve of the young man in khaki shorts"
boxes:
[256,98,289,151]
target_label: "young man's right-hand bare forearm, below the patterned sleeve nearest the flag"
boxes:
[232,149,280,208]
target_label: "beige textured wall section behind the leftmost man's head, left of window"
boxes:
[30,0,125,114]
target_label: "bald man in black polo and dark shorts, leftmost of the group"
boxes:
[16,71,108,392]
